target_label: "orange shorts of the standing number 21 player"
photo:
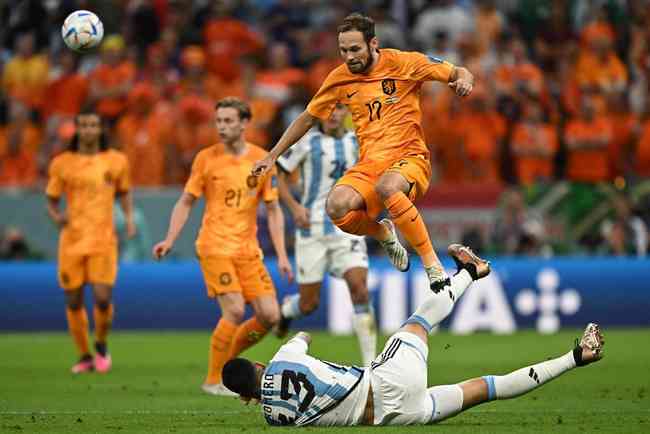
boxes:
[199,256,275,303]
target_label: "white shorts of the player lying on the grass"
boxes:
[370,332,463,425]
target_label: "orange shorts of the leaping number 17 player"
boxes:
[336,155,431,220]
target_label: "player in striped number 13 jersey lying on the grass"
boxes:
[223,244,604,426]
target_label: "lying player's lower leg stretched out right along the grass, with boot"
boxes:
[428,323,605,422]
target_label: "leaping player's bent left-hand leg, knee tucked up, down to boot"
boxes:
[326,174,409,271]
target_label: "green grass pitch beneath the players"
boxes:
[0,329,650,434]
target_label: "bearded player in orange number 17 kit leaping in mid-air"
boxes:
[253,13,474,292]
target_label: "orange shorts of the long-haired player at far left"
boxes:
[58,246,117,291]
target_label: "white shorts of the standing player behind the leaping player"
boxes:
[296,231,368,284]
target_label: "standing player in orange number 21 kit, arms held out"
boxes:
[153,97,293,396]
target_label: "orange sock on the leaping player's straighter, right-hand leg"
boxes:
[384,191,440,268]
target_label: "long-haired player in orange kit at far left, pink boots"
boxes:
[46,112,135,374]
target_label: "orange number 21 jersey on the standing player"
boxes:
[185,143,278,258]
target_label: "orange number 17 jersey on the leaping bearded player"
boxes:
[307,49,454,165]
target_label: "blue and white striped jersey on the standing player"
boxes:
[278,130,359,237]
